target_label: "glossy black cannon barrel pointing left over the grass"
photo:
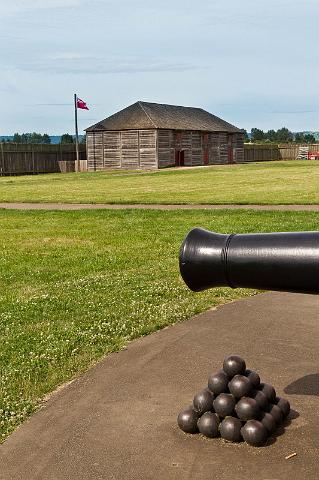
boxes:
[179,228,319,293]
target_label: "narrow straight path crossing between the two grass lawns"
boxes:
[0,203,319,212]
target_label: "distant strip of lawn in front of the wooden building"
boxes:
[0,160,319,204]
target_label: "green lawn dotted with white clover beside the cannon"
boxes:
[0,210,319,438]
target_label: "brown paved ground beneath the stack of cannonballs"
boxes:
[0,293,319,480]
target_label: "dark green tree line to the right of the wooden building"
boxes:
[245,127,316,143]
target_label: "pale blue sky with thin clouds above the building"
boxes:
[0,0,319,135]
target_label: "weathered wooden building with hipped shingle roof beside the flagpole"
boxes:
[86,102,244,171]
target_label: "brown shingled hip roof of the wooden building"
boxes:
[86,102,241,133]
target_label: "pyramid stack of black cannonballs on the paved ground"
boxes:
[177,355,290,446]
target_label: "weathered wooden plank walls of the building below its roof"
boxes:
[87,129,244,170]
